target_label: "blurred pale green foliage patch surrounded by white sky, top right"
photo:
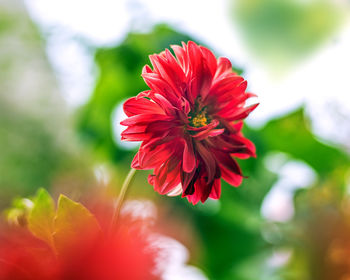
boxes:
[232,0,344,66]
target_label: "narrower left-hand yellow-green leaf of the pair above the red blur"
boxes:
[28,189,55,246]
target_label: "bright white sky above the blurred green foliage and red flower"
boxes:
[25,0,350,149]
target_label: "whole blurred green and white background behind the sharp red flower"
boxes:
[0,0,350,280]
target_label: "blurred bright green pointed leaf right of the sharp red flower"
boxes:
[258,109,350,186]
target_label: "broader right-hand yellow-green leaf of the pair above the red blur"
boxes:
[53,195,100,253]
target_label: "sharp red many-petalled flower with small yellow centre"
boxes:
[121,41,258,204]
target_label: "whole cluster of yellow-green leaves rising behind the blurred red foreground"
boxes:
[8,188,101,254]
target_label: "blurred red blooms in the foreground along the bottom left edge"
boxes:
[0,221,159,280]
